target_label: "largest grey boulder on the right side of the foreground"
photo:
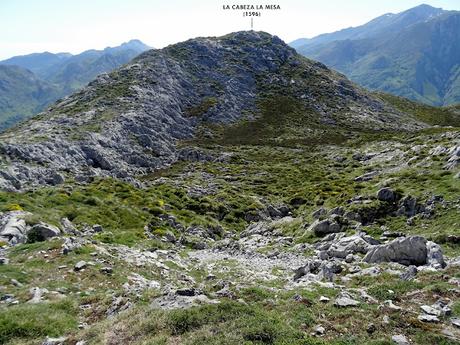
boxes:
[363,236,428,266]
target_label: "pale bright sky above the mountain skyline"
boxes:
[0,0,460,59]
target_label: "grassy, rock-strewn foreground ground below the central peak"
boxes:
[0,124,460,345]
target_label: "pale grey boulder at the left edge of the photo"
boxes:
[0,211,30,245]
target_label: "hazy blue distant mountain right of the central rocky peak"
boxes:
[290,5,460,105]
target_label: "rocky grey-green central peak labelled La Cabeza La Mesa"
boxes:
[0,32,434,191]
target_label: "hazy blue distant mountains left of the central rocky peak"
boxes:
[0,40,151,130]
